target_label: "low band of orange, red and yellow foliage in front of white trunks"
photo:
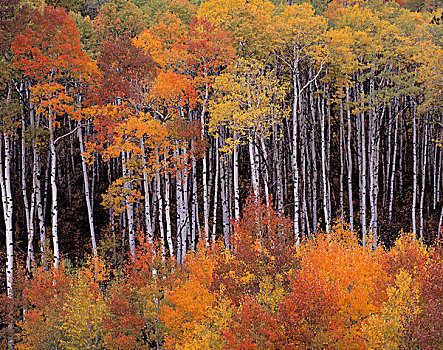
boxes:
[8,195,442,350]
